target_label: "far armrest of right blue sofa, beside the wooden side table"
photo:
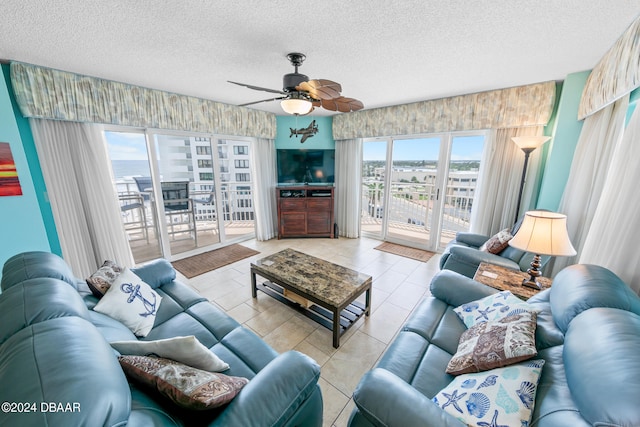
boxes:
[430,270,498,307]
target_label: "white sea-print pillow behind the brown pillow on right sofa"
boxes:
[453,291,539,328]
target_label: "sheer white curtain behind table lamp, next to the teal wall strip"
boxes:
[547,95,629,277]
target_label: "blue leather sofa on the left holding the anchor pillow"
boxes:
[0,252,322,427]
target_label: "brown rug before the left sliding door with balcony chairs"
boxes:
[171,244,260,279]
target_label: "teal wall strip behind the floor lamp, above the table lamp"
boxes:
[536,71,591,211]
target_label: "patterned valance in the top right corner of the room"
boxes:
[578,18,640,120]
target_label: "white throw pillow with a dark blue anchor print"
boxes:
[93,268,162,337]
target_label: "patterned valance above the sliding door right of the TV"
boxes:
[333,81,556,140]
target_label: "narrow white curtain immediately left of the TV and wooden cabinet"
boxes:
[251,138,278,240]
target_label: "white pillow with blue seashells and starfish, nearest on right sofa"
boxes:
[433,359,544,426]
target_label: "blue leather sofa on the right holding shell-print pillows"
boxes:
[349,265,640,427]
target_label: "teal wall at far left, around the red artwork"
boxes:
[0,65,51,278]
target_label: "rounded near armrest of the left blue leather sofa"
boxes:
[211,351,322,426]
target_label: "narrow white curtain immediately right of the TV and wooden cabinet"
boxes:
[334,138,362,238]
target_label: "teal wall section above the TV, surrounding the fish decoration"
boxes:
[275,116,336,150]
